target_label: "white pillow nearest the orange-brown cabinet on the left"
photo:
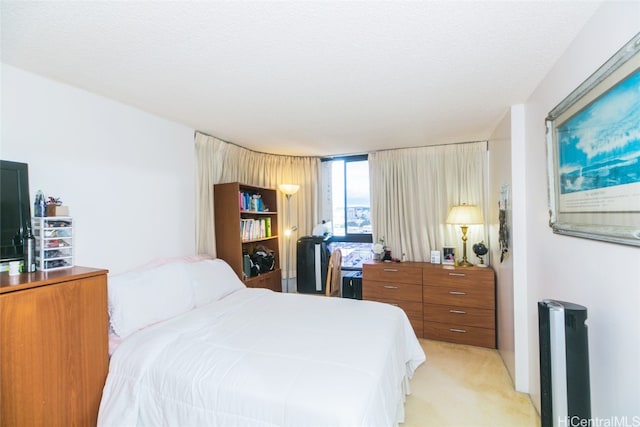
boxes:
[108,263,193,338]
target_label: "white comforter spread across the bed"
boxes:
[98,289,425,427]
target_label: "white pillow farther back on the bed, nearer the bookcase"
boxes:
[185,259,245,307]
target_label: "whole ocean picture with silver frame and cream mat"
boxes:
[546,34,640,246]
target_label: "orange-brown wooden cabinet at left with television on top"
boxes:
[0,267,109,427]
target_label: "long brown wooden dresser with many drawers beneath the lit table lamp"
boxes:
[362,262,496,348]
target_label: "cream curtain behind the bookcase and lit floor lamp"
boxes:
[195,132,320,277]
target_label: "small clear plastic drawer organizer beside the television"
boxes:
[33,216,73,271]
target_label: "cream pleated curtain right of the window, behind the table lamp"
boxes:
[369,141,487,262]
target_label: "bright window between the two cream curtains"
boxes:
[323,155,372,269]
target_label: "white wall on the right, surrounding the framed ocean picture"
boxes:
[512,2,640,420]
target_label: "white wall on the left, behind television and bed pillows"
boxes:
[0,64,195,273]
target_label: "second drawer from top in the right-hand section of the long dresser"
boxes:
[423,284,495,310]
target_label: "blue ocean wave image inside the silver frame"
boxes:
[557,70,640,195]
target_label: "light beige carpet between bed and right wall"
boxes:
[401,339,540,427]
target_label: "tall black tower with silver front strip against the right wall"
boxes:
[538,300,591,427]
